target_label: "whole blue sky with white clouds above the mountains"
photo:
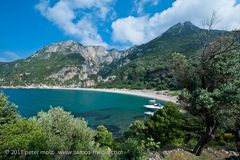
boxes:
[0,0,240,62]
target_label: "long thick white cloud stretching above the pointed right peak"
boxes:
[112,0,240,44]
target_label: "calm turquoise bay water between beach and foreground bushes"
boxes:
[2,89,165,135]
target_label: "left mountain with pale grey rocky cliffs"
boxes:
[0,41,122,86]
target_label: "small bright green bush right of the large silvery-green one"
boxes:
[94,125,113,147]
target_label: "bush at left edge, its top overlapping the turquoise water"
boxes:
[0,93,18,129]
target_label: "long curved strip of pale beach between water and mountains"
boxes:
[0,86,177,103]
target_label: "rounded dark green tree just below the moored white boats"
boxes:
[146,103,185,145]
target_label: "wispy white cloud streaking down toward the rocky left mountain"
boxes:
[36,0,113,46]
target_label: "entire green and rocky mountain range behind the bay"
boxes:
[0,22,234,89]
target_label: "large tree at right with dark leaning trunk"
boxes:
[172,14,240,155]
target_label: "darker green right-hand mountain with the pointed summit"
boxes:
[99,22,228,90]
